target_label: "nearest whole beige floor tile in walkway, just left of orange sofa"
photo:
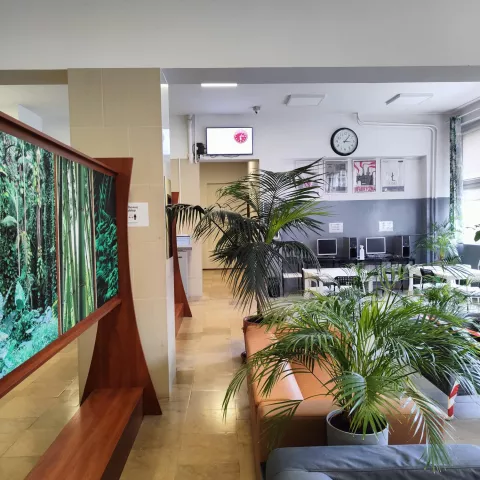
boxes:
[178,433,238,465]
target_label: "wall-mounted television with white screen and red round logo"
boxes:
[207,127,253,155]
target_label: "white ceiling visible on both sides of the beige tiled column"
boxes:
[0,82,480,125]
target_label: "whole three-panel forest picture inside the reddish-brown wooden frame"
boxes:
[0,125,119,378]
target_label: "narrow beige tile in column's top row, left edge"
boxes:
[68,68,103,127]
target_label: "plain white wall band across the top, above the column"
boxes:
[0,0,480,69]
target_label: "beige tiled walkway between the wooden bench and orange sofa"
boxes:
[122,271,255,480]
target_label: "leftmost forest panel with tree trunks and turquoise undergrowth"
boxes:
[0,132,59,378]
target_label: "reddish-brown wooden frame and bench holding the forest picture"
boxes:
[0,112,161,480]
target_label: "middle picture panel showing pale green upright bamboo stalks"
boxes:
[57,158,95,333]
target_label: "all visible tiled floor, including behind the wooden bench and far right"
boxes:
[0,271,480,480]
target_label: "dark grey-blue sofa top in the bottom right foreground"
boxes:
[266,445,480,480]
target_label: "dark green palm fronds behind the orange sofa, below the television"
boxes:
[167,160,327,315]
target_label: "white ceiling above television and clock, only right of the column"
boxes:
[169,82,480,115]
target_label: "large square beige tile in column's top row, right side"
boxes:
[102,68,162,127]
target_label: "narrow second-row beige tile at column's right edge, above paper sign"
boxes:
[129,127,164,186]
